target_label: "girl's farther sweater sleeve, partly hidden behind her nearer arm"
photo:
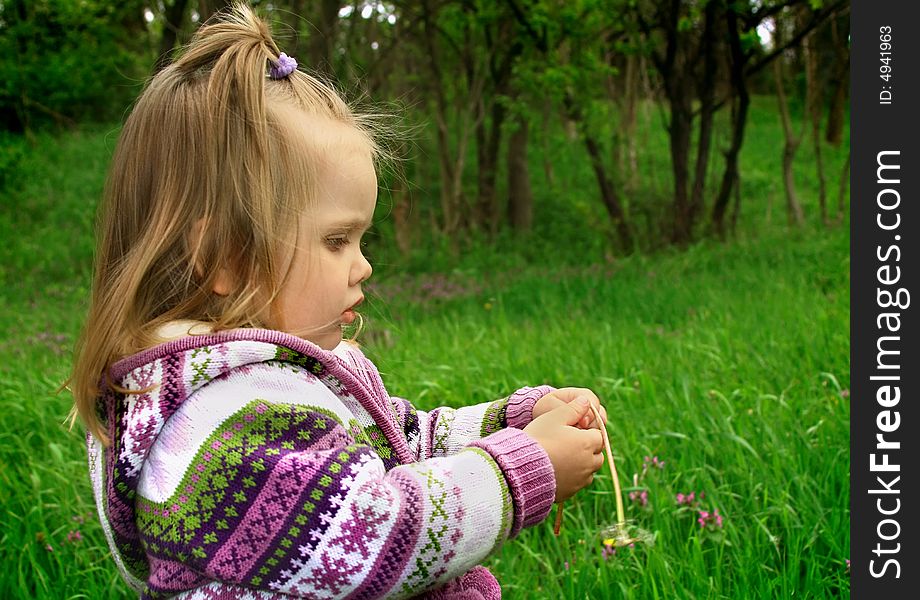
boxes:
[393,385,554,459]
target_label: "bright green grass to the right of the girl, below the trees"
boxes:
[369,224,849,598]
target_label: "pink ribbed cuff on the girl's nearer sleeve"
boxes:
[470,428,556,537]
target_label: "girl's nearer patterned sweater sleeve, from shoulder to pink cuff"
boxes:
[136,366,555,598]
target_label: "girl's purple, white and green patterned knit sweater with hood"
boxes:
[87,329,555,600]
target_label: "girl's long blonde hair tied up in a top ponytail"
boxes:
[69,4,380,443]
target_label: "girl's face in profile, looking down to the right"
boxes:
[275,125,377,350]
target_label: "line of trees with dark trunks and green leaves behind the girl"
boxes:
[0,0,849,252]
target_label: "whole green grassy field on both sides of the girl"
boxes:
[0,99,849,599]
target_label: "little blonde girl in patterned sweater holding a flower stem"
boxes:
[71,6,606,599]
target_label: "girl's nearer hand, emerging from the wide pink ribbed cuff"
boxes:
[524,396,604,502]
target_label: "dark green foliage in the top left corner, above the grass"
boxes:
[0,0,149,131]
